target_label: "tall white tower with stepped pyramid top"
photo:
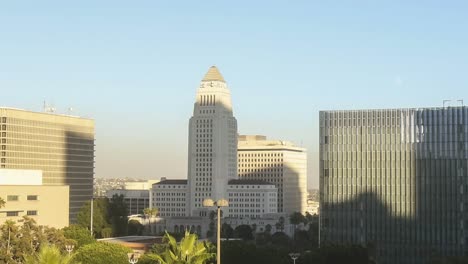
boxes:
[187,66,237,216]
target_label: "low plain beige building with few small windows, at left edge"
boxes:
[0,169,69,228]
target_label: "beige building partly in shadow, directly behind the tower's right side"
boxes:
[237,135,307,214]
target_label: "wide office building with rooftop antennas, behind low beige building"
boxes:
[0,108,94,222]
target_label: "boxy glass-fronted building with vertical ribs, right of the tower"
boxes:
[320,107,468,263]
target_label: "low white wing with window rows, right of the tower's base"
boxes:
[225,180,278,218]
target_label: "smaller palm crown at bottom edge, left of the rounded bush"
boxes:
[24,245,78,264]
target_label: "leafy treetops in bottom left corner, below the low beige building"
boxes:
[0,217,74,263]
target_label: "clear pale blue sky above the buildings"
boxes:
[0,0,468,186]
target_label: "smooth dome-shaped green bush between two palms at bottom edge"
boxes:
[73,242,132,264]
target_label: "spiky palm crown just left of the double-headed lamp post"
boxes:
[148,230,216,264]
